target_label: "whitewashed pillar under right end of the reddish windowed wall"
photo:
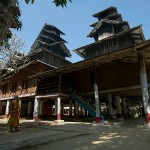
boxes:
[33,96,39,120]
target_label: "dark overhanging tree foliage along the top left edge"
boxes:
[0,0,72,45]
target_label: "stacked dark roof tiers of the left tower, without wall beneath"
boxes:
[29,24,71,58]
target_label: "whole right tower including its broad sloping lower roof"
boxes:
[74,6,145,59]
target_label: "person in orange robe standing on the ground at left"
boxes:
[8,96,20,132]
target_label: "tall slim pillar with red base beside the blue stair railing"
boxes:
[94,66,100,123]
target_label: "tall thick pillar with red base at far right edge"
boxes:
[138,53,150,124]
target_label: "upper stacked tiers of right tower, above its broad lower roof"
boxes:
[88,6,130,41]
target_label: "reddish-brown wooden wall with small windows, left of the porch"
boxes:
[0,63,50,98]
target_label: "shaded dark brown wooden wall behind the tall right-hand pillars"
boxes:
[72,62,145,93]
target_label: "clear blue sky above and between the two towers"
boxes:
[15,0,150,62]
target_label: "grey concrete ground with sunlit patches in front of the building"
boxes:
[0,119,150,150]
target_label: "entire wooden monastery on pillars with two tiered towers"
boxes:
[0,7,150,124]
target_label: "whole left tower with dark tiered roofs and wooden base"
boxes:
[29,24,71,67]
